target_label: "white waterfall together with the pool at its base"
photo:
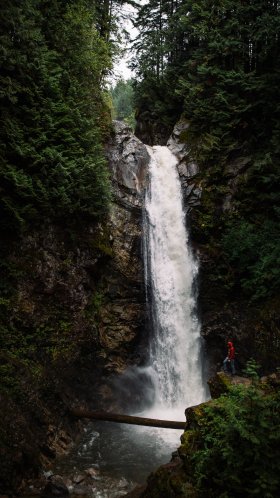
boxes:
[51,147,208,492]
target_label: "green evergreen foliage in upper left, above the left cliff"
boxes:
[0,0,111,229]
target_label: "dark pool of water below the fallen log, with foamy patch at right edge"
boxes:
[51,422,182,498]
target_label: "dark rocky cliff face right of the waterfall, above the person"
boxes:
[168,120,279,375]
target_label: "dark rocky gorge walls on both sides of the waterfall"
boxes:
[0,117,280,493]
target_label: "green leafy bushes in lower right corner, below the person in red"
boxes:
[183,385,280,498]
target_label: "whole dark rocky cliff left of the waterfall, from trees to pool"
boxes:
[0,123,149,494]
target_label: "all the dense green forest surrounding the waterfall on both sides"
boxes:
[0,0,280,498]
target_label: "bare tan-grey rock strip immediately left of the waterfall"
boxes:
[99,122,149,372]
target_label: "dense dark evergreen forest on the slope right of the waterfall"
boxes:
[133,0,280,300]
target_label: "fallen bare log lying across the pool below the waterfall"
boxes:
[70,408,186,429]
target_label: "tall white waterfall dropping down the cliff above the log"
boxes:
[144,146,207,418]
